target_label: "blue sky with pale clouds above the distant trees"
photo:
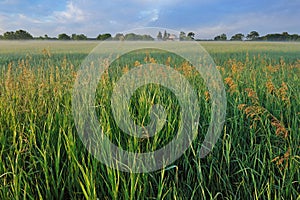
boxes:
[0,0,300,38]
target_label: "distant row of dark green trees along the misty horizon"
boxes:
[0,30,300,41]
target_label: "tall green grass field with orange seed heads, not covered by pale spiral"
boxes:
[0,42,300,200]
